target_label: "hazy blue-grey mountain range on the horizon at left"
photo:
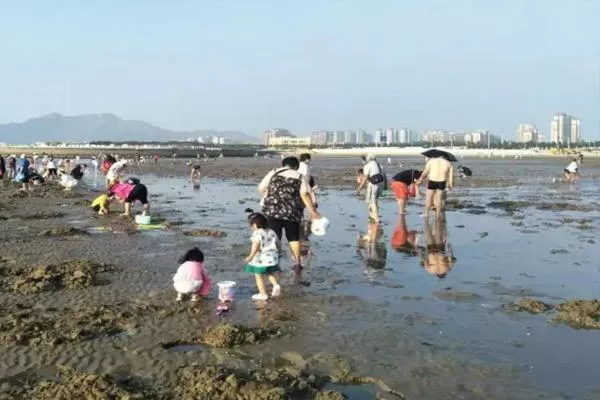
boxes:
[0,113,259,144]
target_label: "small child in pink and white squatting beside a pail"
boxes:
[173,247,212,301]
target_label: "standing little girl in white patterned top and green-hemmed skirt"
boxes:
[244,212,281,301]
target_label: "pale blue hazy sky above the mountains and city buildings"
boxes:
[0,0,600,140]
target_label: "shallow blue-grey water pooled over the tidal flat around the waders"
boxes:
[85,160,600,398]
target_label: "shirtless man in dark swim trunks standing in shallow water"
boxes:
[417,157,454,218]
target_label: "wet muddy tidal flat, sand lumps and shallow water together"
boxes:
[0,159,600,399]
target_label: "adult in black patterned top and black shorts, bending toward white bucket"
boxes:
[258,157,321,284]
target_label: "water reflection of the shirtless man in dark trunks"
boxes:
[421,219,456,279]
